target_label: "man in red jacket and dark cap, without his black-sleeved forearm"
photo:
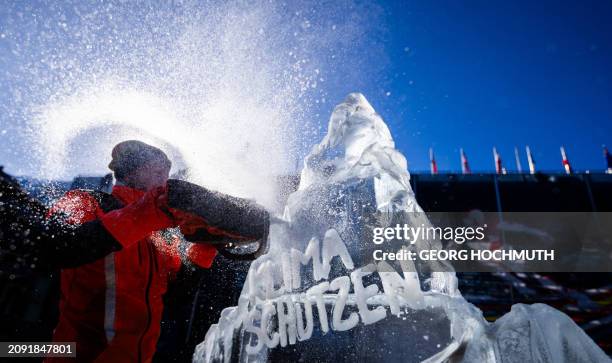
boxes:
[47,140,216,362]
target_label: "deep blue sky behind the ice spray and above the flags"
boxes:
[0,0,612,176]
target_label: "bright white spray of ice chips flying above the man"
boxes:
[0,0,388,205]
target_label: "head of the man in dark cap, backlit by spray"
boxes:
[108,140,172,191]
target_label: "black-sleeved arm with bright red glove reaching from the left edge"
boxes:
[0,167,174,275]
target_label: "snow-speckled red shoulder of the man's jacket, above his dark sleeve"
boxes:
[47,190,104,224]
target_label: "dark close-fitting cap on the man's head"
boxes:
[108,140,172,180]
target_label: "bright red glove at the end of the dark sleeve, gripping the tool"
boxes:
[100,187,178,248]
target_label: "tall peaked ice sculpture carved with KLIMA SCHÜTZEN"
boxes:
[194,93,607,362]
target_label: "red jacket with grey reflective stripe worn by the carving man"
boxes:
[46,186,216,363]
